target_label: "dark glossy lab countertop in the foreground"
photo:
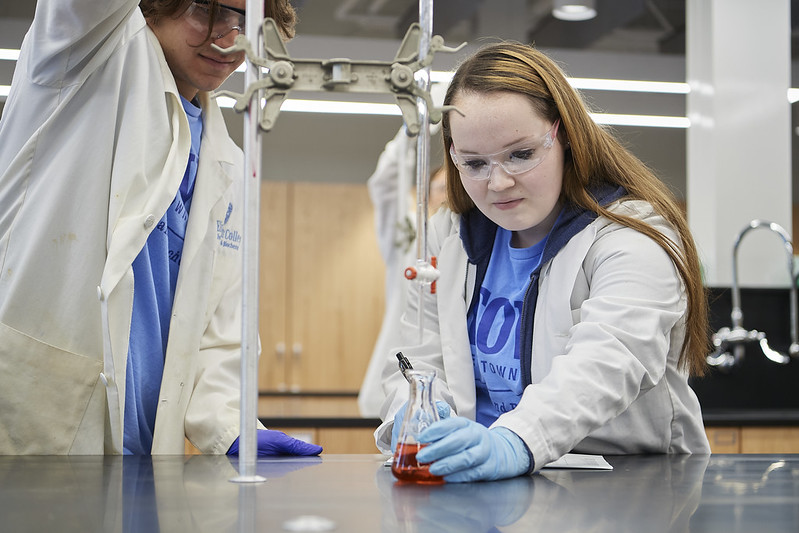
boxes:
[0,455,799,533]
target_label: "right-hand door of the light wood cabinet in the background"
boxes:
[288,183,385,392]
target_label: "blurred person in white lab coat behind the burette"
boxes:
[358,123,446,417]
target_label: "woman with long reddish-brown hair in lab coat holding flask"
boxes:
[375,43,710,482]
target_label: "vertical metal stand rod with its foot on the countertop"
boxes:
[231,0,265,482]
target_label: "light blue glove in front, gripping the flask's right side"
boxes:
[416,416,532,483]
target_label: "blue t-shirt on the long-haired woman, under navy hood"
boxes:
[467,228,547,426]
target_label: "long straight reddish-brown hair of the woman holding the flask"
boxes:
[442,42,711,375]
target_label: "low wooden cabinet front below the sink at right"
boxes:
[705,426,799,453]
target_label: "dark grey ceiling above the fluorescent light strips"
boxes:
[0,0,685,54]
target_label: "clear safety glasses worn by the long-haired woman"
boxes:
[449,119,560,181]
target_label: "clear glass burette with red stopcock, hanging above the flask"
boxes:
[416,0,433,344]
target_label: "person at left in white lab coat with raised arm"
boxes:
[0,0,321,455]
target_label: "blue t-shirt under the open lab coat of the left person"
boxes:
[123,97,203,455]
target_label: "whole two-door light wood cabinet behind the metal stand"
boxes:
[259,182,385,392]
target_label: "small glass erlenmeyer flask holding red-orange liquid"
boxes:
[391,370,444,483]
